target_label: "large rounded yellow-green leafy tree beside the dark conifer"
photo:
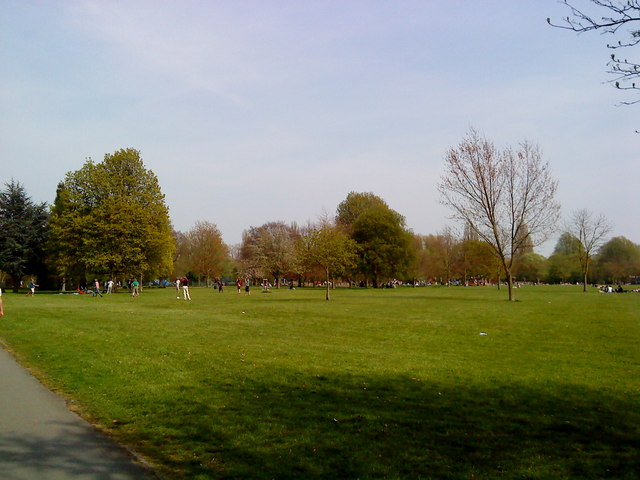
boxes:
[51,148,175,284]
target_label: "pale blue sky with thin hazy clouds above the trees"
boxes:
[0,0,640,255]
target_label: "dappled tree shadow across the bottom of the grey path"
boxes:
[0,422,157,480]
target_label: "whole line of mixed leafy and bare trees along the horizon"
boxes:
[0,137,640,299]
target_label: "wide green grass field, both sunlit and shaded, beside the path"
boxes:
[0,286,640,479]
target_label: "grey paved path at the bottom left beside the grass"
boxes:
[0,347,157,480]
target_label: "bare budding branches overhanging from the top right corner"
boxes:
[547,0,640,105]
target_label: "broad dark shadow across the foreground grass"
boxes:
[146,376,640,479]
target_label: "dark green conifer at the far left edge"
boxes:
[0,181,49,292]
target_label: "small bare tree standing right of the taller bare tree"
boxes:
[567,209,611,292]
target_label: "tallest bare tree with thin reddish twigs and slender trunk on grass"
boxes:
[438,129,560,300]
